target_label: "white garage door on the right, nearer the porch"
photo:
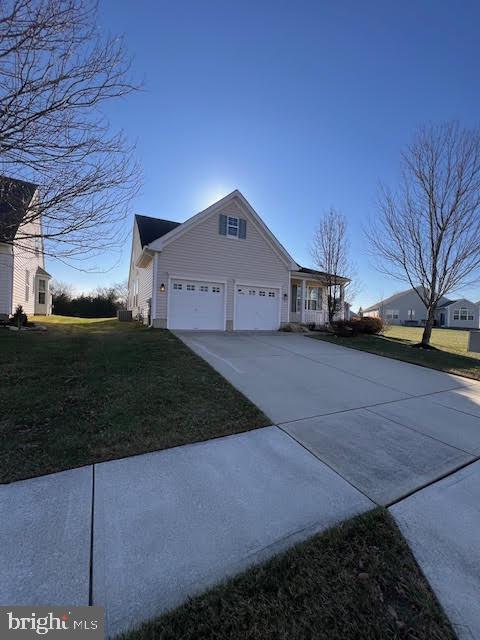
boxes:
[234,285,280,330]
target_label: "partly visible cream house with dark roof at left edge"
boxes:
[0,176,52,317]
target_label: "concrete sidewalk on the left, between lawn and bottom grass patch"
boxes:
[0,427,374,635]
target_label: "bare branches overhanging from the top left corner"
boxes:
[0,0,139,262]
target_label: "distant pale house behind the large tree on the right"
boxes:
[363,289,479,329]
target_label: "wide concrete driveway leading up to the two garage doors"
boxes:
[177,332,480,505]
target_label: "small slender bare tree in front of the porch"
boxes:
[311,208,355,323]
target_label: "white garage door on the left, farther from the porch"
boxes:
[168,280,225,331]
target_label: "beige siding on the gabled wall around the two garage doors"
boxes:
[154,201,289,327]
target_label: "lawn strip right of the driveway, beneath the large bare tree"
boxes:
[314,326,480,380]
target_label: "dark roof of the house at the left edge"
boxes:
[0,176,38,242]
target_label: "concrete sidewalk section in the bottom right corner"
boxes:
[390,462,480,640]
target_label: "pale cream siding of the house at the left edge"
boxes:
[12,215,45,315]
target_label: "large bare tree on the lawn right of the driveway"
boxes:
[367,122,480,348]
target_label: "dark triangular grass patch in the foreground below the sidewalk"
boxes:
[122,509,455,640]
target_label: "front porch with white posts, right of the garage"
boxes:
[289,270,346,326]
